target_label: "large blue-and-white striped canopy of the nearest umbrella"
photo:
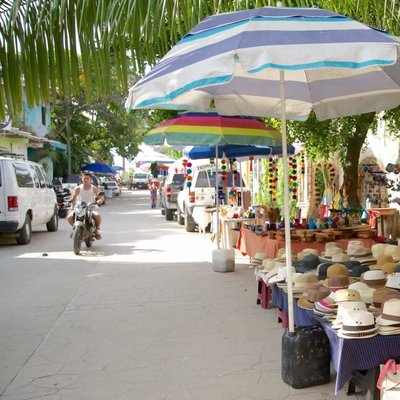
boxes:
[126,7,400,120]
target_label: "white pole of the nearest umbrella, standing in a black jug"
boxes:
[279,71,294,333]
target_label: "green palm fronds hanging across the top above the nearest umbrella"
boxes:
[0,0,400,119]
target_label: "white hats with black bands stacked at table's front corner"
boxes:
[338,310,378,339]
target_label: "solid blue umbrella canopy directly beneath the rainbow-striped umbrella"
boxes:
[183,144,295,160]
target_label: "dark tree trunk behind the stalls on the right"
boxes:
[341,113,375,208]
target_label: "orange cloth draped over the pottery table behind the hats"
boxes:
[236,227,375,258]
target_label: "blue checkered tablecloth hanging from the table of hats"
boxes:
[272,285,400,394]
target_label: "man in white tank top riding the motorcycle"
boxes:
[67,172,101,240]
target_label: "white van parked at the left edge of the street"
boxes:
[0,153,58,244]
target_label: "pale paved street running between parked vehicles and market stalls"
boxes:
[0,191,362,400]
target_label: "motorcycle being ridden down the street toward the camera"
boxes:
[72,201,98,255]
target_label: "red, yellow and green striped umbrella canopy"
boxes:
[144,112,281,146]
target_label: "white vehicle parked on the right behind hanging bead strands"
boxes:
[176,160,247,232]
